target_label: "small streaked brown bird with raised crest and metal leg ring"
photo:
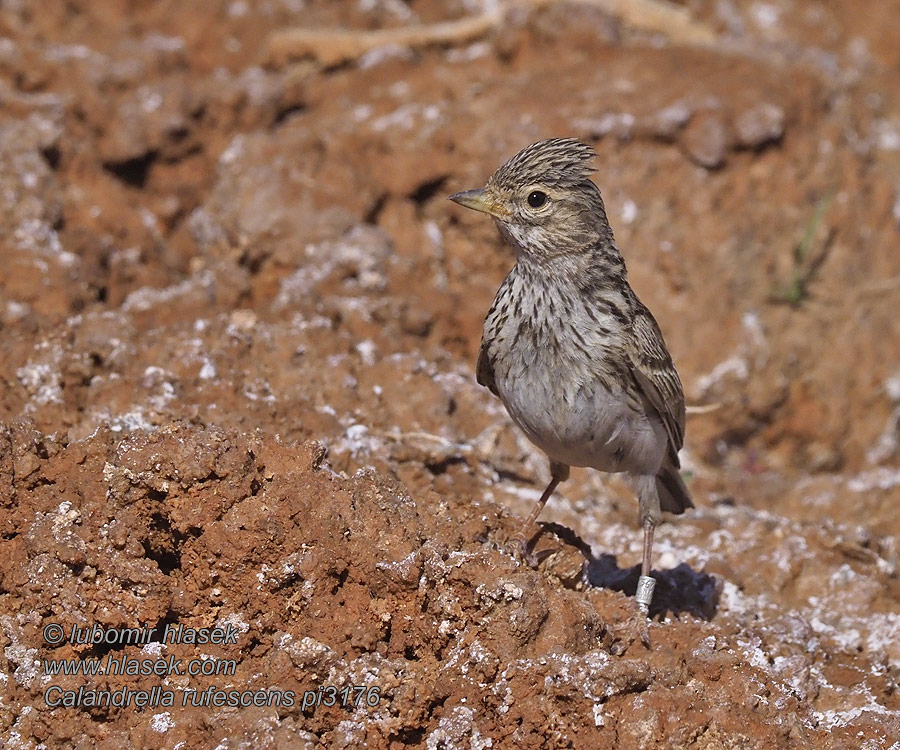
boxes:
[450,138,693,613]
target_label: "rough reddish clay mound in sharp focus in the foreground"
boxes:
[2,425,884,747]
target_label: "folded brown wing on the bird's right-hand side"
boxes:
[628,302,684,458]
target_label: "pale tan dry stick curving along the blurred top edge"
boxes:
[268,0,715,67]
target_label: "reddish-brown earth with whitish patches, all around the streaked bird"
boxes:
[0,0,900,750]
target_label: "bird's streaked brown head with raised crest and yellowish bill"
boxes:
[450,138,612,260]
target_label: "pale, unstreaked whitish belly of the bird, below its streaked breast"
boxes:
[497,365,667,474]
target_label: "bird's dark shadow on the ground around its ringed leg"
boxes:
[541,522,721,621]
